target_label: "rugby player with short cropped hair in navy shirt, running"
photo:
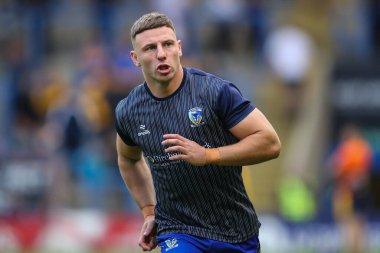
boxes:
[116,13,281,253]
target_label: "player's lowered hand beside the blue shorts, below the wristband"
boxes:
[139,215,157,251]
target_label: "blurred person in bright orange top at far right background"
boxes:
[331,124,373,253]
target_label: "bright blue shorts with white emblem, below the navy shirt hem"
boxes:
[157,234,260,253]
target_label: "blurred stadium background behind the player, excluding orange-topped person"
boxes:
[0,0,380,253]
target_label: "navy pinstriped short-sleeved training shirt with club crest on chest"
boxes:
[116,68,260,243]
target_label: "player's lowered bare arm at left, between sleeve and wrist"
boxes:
[116,135,154,208]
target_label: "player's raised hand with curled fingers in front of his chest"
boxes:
[162,134,206,166]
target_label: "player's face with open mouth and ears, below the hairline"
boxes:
[131,27,182,84]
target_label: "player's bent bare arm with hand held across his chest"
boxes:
[162,108,281,165]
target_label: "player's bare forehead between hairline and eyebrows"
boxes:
[135,26,177,47]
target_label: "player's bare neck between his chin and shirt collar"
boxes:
[146,66,183,98]
